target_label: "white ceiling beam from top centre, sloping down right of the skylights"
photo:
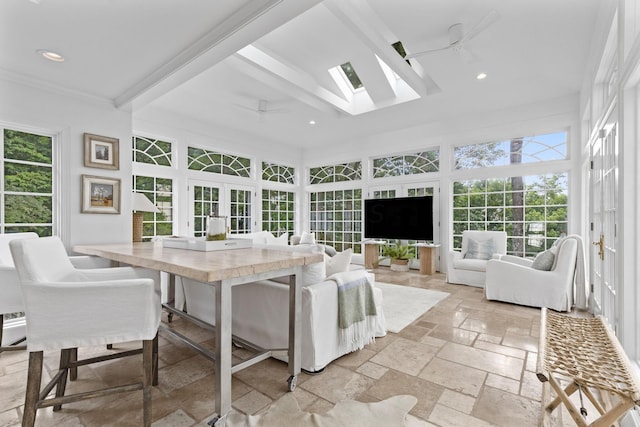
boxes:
[323,0,440,97]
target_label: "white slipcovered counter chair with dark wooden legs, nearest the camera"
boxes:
[9,237,161,426]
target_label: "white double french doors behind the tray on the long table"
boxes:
[187,180,256,237]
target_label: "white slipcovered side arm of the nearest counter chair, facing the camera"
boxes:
[23,278,161,351]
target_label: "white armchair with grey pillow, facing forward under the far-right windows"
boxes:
[447,230,507,287]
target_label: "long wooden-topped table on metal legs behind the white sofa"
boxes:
[72,242,324,425]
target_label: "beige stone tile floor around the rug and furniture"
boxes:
[0,268,596,427]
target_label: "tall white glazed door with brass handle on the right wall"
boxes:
[585,112,619,330]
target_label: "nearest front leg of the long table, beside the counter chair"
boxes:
[214,281,232,419]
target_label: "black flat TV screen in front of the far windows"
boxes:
[364,196,433,241]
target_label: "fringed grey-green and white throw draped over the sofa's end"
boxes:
[329,271,377,353]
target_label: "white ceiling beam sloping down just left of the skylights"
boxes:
[237,45,354,115]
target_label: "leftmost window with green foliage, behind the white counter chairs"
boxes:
[0,129,54,236]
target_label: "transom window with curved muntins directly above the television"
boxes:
[373,150,440,178]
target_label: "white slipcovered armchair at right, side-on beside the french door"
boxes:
[485,239,578,311]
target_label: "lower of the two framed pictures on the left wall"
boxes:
[82,175,120,214]
